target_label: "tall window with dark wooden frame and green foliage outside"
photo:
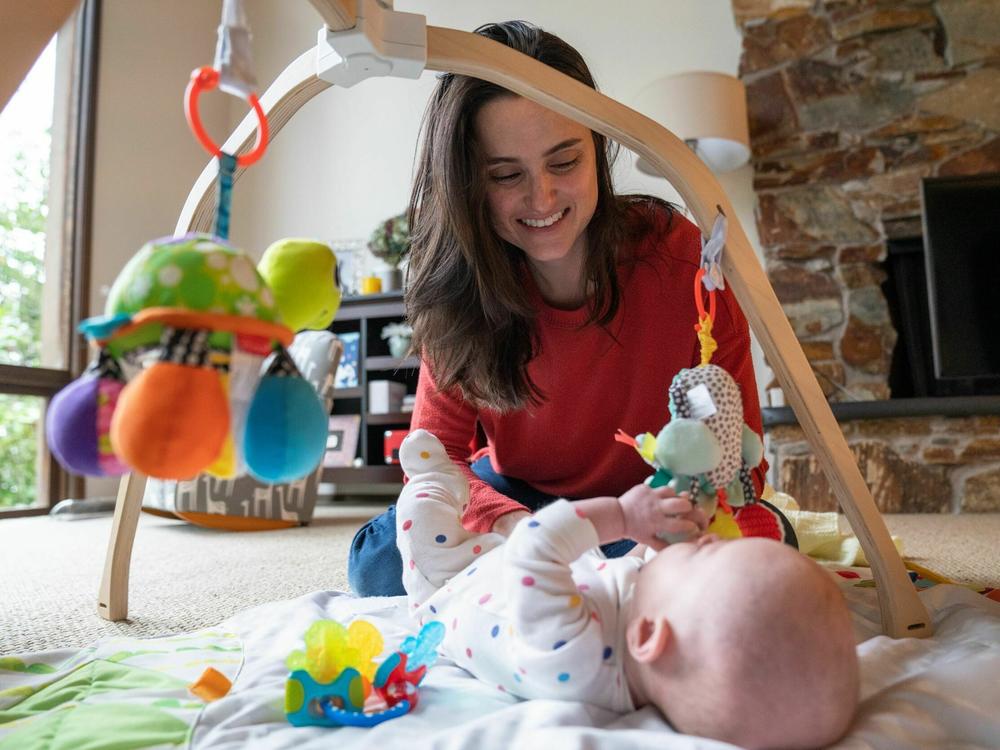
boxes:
[0,0,98,515]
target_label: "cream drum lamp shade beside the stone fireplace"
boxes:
[635,71,750,177]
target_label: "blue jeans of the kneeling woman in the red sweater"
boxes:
[347,456,635,596]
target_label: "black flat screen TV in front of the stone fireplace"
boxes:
[922,174,1000,395]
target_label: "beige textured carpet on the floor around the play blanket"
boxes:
[0,503,1000,654]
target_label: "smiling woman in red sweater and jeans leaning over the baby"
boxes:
[348,21,763,596]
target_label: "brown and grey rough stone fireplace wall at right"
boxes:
[733,0,1000,512]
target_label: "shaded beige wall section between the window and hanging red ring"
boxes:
[90,0,230,314]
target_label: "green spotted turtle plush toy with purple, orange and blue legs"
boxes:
[46,234,340,483]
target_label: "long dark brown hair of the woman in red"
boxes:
[406,21,668,411]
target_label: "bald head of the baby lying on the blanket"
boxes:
[627,538,858,748]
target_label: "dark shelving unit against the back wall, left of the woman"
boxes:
[321,292,420,485]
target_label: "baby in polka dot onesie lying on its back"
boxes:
[396,430,858,748]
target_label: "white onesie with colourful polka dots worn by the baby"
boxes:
[396,430,642,712]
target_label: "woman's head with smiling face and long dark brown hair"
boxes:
[406,21,629,418]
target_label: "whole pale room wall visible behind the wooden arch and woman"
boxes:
[91,0,757,312]
